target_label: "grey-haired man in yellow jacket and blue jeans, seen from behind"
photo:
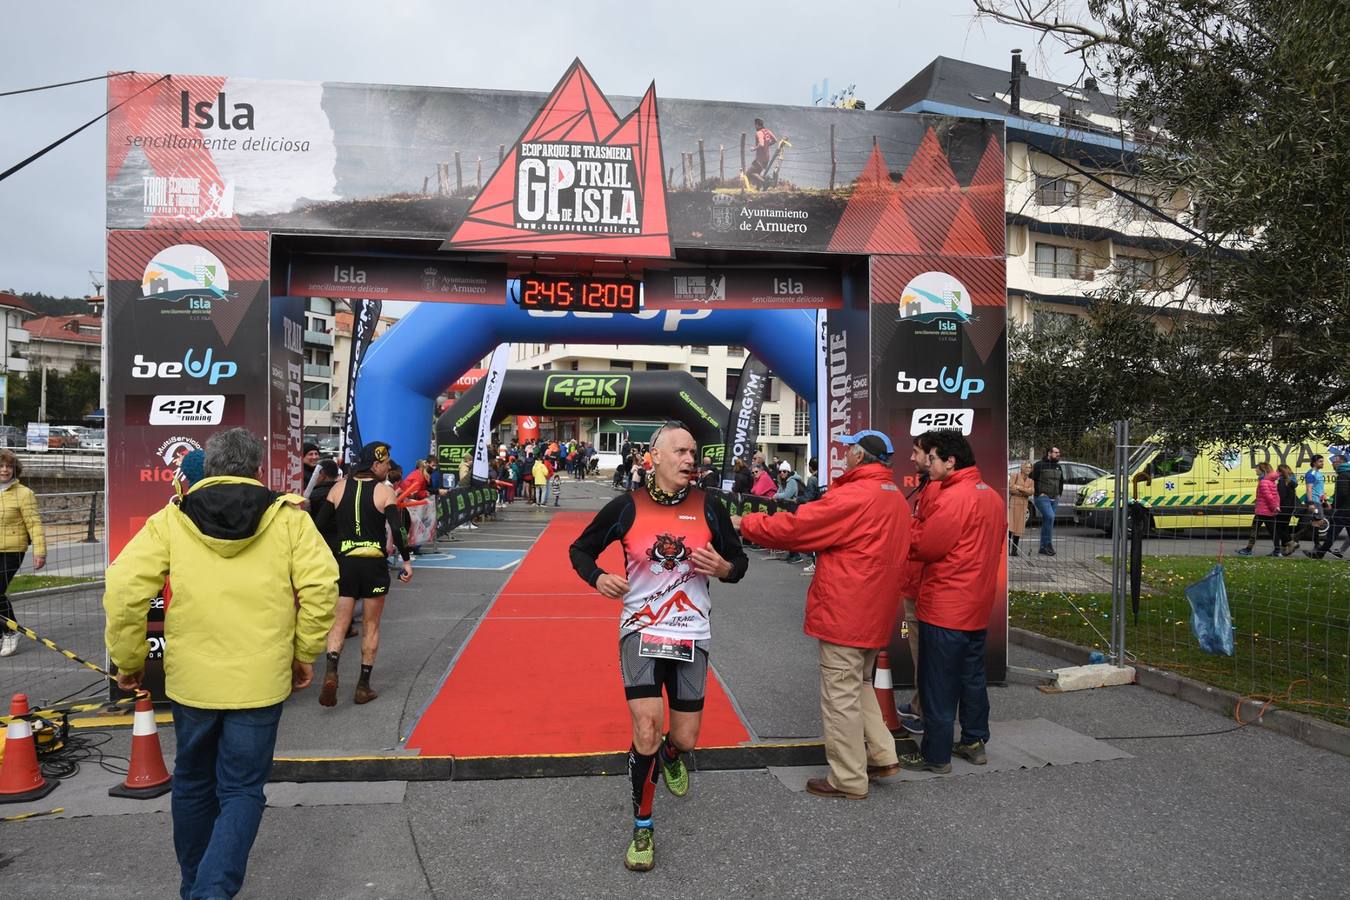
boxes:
[103,428,338,897]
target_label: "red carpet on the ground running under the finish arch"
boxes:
[408,513,749,756]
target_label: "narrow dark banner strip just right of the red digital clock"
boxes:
[643,267,844,309]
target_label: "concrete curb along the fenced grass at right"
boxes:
[1008,627,1350,757]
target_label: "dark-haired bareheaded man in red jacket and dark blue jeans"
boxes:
[900,432,1007,773]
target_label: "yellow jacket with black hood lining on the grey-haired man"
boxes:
[103,478,338,710]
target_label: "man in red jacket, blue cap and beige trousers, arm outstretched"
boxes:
[732,430,910,800]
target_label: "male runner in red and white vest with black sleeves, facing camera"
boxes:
[571,422,749,872]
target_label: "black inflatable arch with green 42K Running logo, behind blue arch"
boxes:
[436,371,728,471]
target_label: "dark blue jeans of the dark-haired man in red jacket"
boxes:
[919,622,990,765]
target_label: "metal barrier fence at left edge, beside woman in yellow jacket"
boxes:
[0,491,105,704]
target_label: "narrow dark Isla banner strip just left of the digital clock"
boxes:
[288,254,506,306]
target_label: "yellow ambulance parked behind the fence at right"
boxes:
[1073,422,1350,534]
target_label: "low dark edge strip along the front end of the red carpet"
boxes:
[269,741,825,781]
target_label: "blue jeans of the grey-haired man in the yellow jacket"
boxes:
[173,703,281,900]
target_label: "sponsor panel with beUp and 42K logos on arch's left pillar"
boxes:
[107,229,270,559]
